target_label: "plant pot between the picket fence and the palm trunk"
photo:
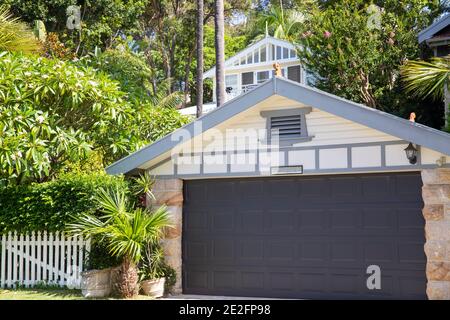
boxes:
[81,268,111,298]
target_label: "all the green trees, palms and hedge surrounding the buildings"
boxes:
[0,0,450,296]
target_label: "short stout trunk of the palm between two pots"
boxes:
[112,258,139,298]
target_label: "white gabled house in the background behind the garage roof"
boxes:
[180,36,312,116]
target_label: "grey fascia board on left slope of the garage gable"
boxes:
[106,80,275,175]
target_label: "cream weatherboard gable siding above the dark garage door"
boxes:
[146,95,450,178]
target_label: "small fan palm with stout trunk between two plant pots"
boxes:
[68,188,171,298]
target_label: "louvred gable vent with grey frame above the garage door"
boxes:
[261,107,313,146]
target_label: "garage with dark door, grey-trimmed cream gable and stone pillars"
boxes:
[107,77,450,300]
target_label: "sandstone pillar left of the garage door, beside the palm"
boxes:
[150,179,183,294]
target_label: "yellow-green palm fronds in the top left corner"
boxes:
[0,6,40,53]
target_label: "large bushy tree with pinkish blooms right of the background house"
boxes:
[298,0,440,112]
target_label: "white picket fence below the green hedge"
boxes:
[0,231,90,288]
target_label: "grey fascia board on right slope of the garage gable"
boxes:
[275,78,450,155]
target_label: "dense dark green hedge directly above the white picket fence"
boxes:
[0,173,128,234]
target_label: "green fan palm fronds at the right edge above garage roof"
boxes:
[401,55,450,99]
